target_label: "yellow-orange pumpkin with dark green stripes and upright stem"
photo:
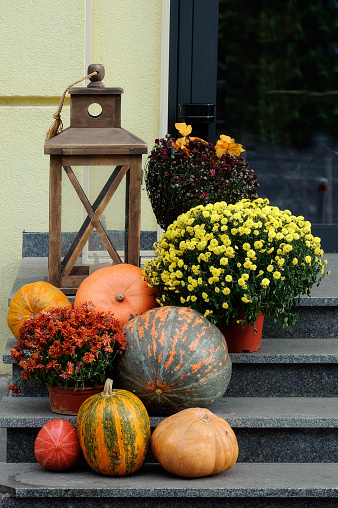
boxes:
[76,379,150,476]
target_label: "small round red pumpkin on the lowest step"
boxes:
[34,419,81,471]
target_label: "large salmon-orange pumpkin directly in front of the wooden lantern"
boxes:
[74,263,157,326]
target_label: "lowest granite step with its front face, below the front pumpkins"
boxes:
[0,463,338,508]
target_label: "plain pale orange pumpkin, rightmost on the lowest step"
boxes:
[151,407,238,478]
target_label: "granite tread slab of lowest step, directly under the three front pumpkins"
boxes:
[0,463,338,499]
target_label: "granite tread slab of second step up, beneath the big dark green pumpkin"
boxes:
[0,396,338,432]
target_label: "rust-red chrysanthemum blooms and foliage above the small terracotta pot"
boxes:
[8,304,126,393]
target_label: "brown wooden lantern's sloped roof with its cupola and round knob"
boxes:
[44,64,148,155]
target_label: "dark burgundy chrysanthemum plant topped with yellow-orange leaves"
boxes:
[145,123,260,230]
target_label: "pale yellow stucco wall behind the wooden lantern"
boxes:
[0,0,162,374]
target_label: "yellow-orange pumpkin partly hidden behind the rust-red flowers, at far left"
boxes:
[7,281,72,339]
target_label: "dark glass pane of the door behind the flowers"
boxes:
[217,0,338,224]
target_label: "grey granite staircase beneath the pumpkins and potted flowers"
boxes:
[0,254,338,508]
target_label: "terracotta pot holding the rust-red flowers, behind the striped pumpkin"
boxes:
[47,385,104,415]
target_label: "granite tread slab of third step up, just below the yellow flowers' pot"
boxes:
[3,337,338,364]
